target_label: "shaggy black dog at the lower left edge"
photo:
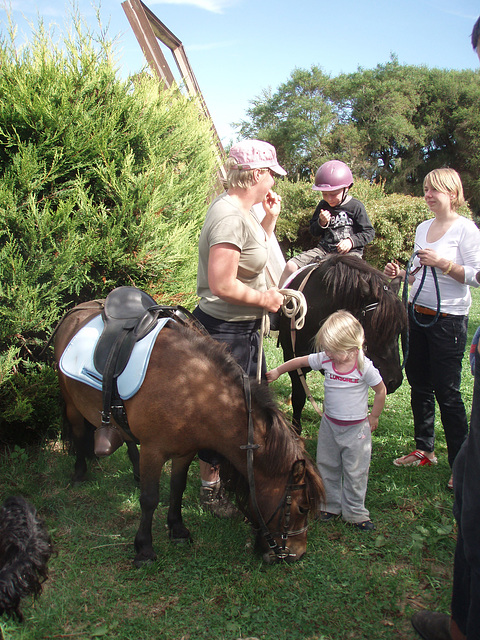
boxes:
[0,497,53,622]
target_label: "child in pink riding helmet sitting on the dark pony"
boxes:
[278,160,375,287]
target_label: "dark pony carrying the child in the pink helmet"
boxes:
[279,254,407,433]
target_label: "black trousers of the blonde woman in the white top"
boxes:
[405,314,468,466]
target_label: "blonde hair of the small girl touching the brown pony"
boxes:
[315,309,365,371]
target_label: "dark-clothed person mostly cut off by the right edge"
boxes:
[406,18,480,640]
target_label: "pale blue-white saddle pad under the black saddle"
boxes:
[59,314,170,400]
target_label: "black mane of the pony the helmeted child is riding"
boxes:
[318,254,407,343]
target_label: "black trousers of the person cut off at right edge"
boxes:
[452,354,480,640]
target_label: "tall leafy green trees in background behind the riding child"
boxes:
[241,56,480,214]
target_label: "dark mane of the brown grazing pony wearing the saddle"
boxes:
[175,325,323,505]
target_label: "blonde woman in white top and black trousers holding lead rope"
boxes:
[385,168,480,489]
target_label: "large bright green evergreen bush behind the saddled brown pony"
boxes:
[0,16,217,443]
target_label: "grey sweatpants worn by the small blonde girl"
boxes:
[317,415,372,522]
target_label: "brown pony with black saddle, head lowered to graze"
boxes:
[55,303,324,566]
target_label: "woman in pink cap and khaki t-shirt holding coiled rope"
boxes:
[193,140,286,517]
